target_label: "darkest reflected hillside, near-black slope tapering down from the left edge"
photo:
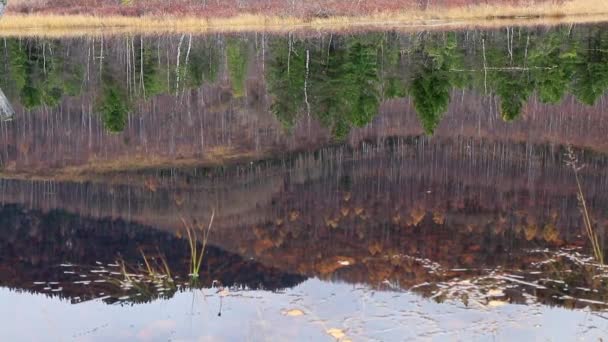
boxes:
[0,205,304,303]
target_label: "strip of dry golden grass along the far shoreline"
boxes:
[0,0,608,36]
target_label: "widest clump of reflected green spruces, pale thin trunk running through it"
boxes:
[268,37,381,140]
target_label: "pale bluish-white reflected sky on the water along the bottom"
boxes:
[0,280,608,341]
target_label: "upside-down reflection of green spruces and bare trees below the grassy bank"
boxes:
[0,26,608,177]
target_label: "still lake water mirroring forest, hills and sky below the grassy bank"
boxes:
[0,25,608,342]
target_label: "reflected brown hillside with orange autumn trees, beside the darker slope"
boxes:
[0,137,608,309]
